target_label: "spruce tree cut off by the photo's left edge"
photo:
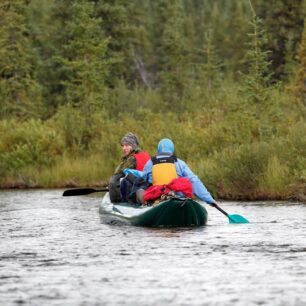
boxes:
[0,0,41,118]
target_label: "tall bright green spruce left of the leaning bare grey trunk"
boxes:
[53,0,109,150]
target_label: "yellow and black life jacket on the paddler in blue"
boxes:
[152,154,178,185]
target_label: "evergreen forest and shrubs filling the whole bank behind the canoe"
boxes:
[0,0,306,199]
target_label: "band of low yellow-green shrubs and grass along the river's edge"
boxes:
[0,87,306,204]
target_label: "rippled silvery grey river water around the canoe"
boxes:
[0,190,306,306]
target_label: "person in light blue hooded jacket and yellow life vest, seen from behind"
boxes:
[137,138,217,204]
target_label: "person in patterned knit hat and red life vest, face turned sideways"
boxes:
[108,132,150,202]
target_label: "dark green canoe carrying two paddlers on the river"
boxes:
[99,193,208,227]
